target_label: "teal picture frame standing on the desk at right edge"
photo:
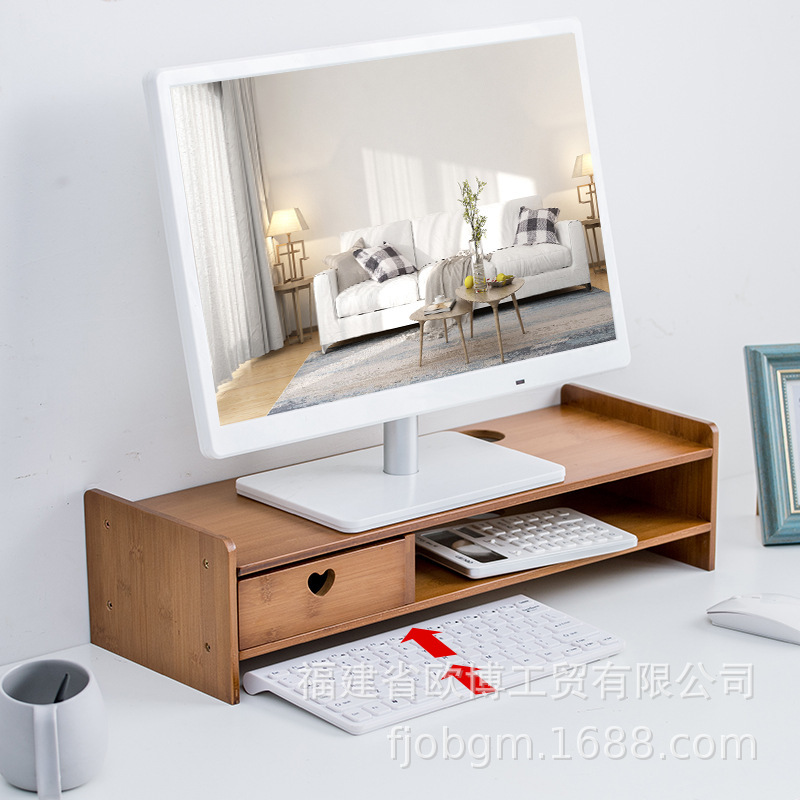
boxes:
[744,344,800,545]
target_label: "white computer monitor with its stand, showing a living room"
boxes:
[145,20,629,531]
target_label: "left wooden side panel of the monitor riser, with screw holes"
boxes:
[84,490,239,703]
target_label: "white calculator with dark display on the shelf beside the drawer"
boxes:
[416,508,639,578]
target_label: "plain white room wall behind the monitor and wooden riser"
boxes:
[0,0,800,662]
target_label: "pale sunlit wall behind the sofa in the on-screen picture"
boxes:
[255,34,590,266]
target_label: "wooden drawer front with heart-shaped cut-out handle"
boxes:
[239,536,414,650]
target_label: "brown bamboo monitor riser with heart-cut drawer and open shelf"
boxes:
[85,385,718,703]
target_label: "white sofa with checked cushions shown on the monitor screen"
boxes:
[314,196,591,353]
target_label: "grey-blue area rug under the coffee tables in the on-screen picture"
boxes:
[269,288,615,414]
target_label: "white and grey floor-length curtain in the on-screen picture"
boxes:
[172,81,283,387]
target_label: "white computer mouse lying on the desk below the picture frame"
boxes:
[706,593,800,644]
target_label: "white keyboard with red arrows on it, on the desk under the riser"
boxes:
[243,595,622,734]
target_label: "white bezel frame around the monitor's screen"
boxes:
[145,19,630,458]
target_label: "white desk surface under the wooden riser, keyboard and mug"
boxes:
[0,478,800,800]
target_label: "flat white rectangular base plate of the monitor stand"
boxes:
[236,431,565,533]
